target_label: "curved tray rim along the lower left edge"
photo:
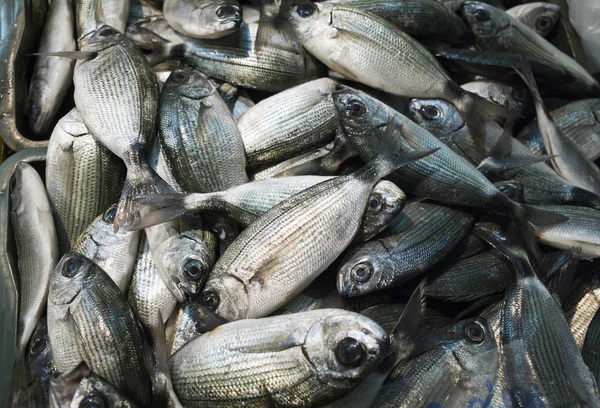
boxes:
[0,147,47,407]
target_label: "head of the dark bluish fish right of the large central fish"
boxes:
[337,240,387,297]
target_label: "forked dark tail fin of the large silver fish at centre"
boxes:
[367,116,439,180]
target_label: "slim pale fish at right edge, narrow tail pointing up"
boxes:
[517,56,600,194]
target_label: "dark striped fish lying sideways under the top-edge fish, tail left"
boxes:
[128,21,322,92]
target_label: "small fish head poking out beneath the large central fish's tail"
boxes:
[362,180,406,239]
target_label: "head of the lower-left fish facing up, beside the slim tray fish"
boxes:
[48,252,101,305]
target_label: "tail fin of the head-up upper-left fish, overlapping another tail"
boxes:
[114,165,174,232]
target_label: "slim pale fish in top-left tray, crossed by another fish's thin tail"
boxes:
[27,0,75,136]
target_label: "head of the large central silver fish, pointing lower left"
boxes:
[200,274,250,322]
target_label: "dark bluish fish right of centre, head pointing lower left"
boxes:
[337,202,473,297]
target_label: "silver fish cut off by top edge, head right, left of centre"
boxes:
[163,0,242,38]
